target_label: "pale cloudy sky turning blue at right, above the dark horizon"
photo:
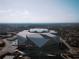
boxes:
[0,0,79,23]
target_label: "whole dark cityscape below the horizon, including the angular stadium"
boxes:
[0,23,79,59]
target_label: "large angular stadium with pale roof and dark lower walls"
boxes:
[17,28,60,56]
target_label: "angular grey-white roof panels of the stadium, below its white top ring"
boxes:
[17,30,59,48]
